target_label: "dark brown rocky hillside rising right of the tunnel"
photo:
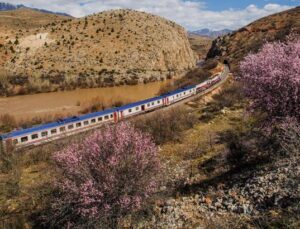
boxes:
[207,7,300,71]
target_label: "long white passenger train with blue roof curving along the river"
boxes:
[0,66,226,151]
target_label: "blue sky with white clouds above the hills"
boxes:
[7,0,300,30]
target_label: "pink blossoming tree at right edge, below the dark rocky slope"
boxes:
[240,36,300,121]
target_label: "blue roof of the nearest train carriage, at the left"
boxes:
[1,109,116,139]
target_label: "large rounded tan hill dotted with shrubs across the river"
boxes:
[0,10,196,94]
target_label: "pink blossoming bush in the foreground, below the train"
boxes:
[52,123,160,226]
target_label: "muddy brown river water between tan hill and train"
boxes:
[0,80,171,121]
